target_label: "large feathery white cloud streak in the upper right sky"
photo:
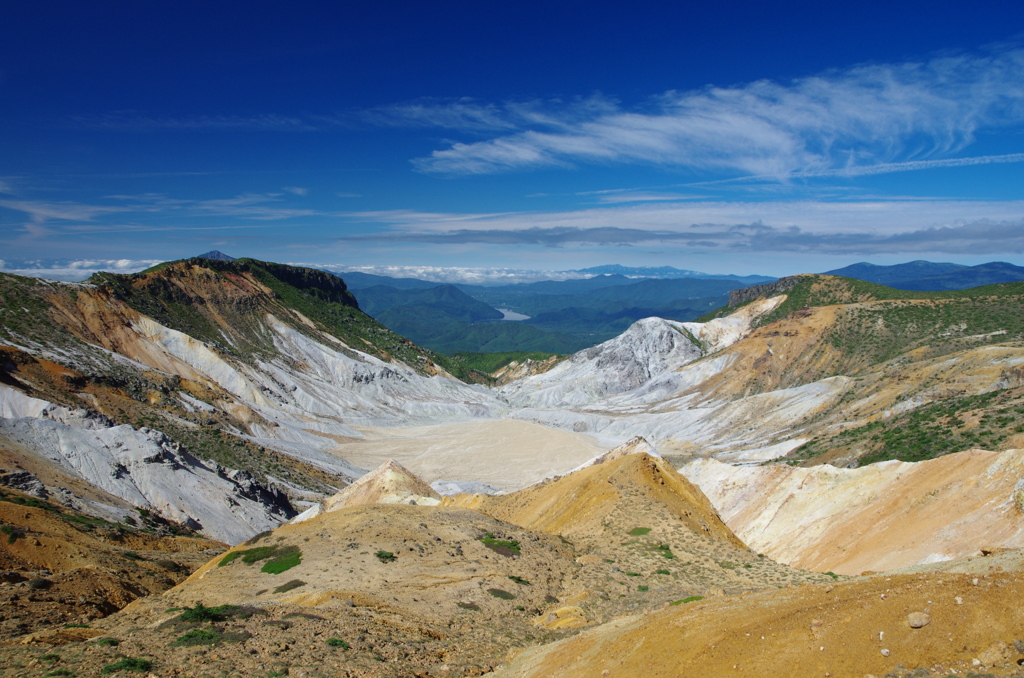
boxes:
[414,47,1024,179]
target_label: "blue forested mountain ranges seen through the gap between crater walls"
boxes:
[340,268,749,354]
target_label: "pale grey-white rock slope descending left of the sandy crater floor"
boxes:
[62,307,505,478]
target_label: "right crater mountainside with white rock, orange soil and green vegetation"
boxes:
[500,276,1024,465]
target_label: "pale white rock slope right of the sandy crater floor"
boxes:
[499,295,847,462]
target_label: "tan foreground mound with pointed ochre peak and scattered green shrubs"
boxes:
[0,442,835,676]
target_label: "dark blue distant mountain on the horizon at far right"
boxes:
[825,260,1024,292]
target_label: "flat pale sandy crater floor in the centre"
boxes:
[334,419,607,491]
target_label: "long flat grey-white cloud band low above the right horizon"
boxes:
[340,200,1024,255]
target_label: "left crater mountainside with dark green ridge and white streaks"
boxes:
[0,259,500,542]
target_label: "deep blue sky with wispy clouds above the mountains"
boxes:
[0,0,1024,279]
